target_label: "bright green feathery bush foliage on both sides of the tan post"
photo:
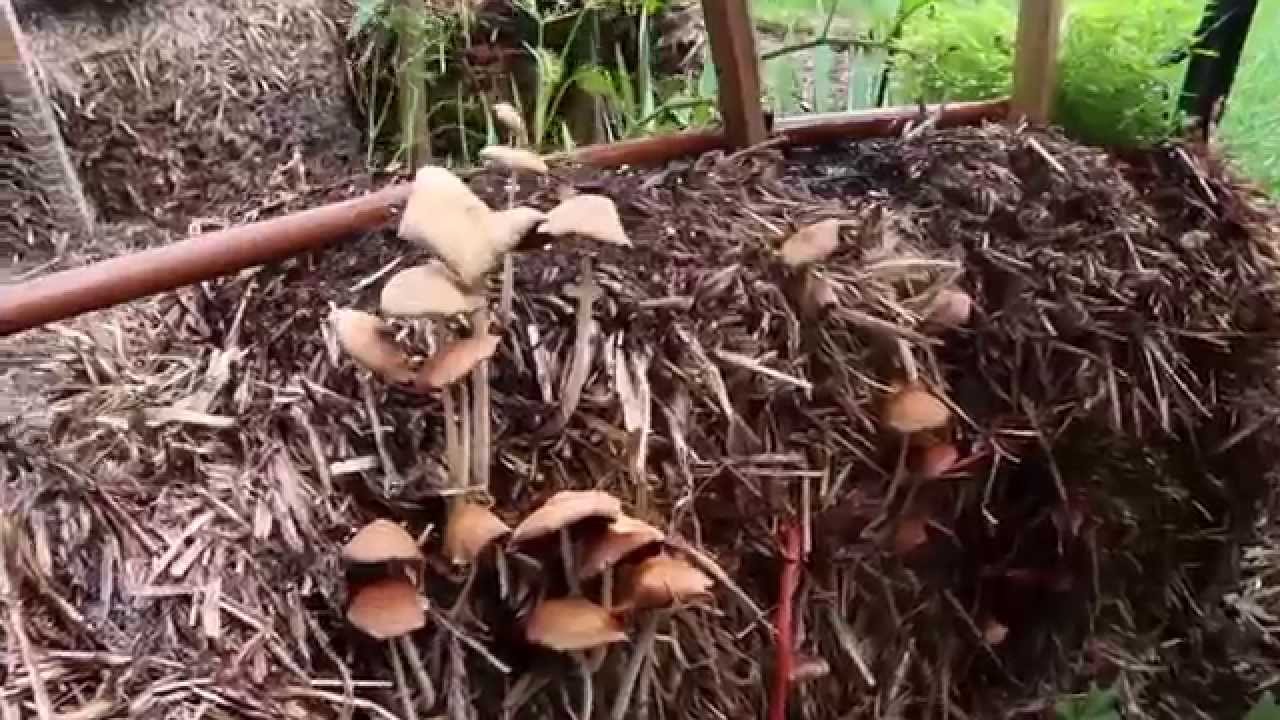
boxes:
[895,0,1201,146]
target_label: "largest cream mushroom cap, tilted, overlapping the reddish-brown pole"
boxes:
[399,165,498,284]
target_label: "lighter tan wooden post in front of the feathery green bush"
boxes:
[1010,0,1064,124]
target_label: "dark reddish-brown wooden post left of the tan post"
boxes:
[703,0,768,147]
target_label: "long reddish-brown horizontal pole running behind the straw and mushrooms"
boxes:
[0,100,1007,337]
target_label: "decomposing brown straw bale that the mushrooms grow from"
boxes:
[0,126,1280,717]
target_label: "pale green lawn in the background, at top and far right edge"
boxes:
[751,0,1280,195]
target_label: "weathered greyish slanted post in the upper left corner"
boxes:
[0,0,93,237]
